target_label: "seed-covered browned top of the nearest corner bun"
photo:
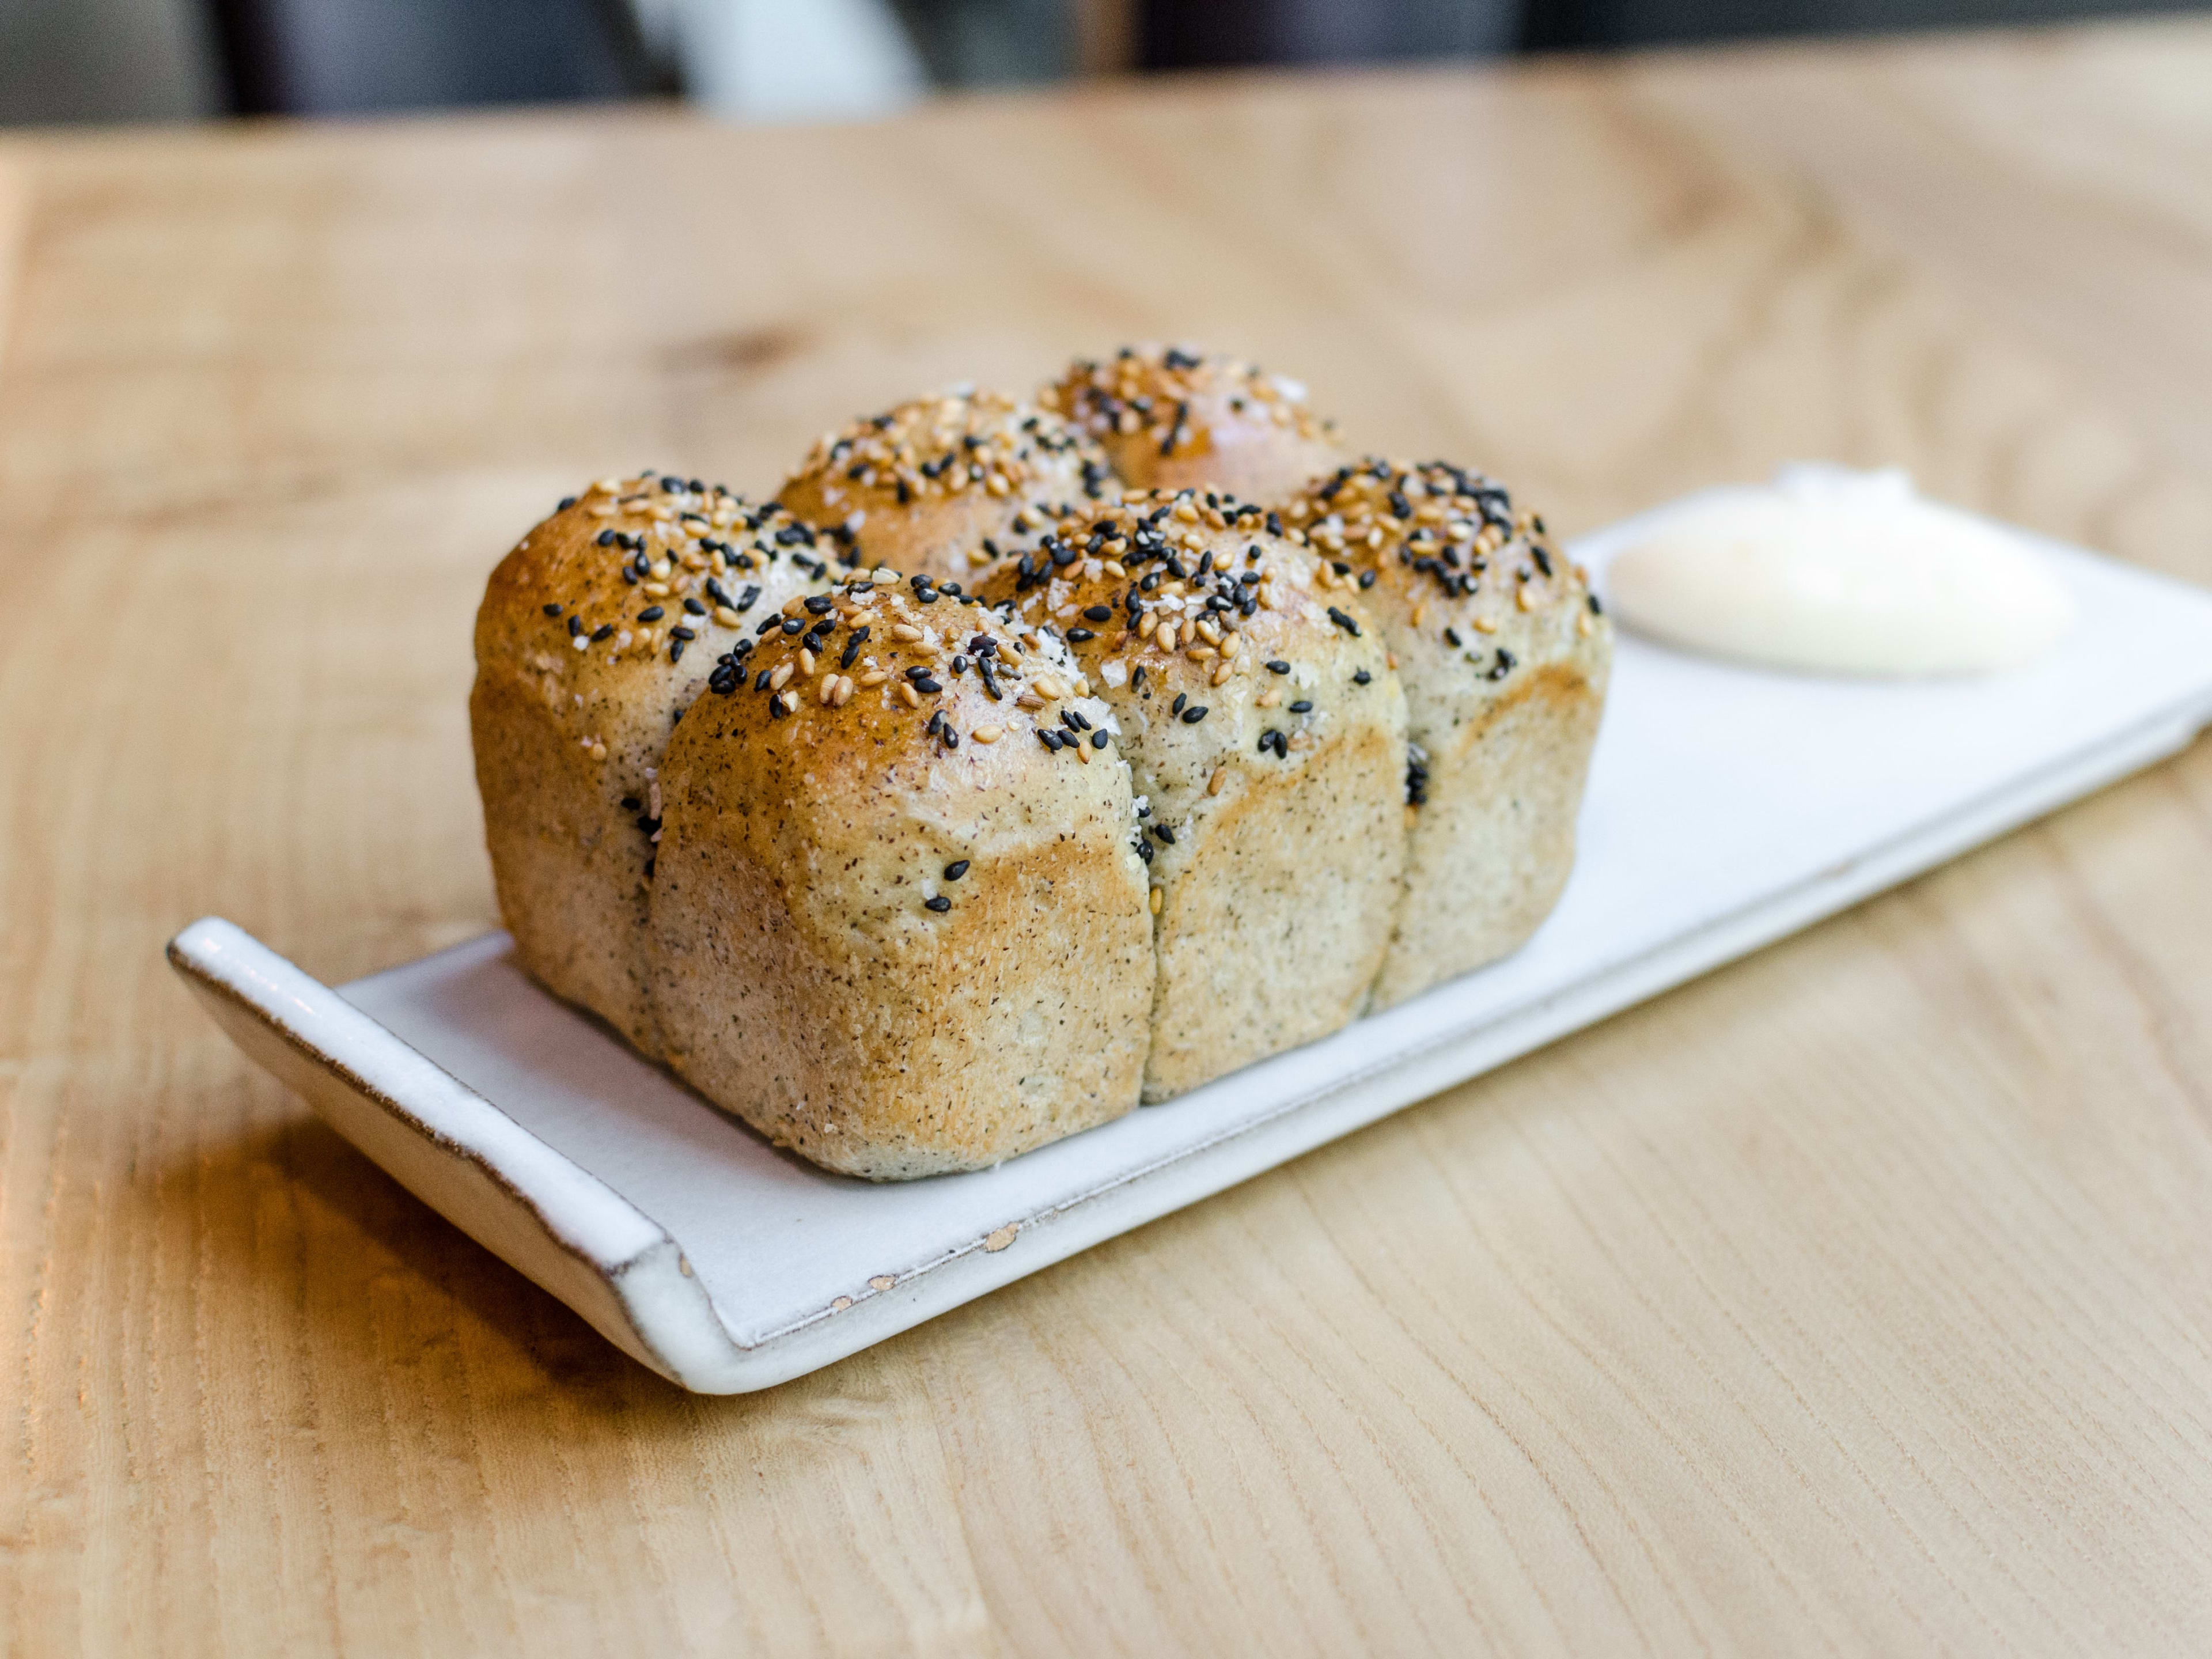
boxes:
[685,569,1123,787]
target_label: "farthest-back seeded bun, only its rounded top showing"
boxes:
[1037,345,1345,502]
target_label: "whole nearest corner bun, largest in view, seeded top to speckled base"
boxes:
[653,569,1153,1179]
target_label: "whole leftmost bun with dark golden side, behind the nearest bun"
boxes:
[469,476,827,1055]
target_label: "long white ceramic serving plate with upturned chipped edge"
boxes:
[168,495,2212,1393]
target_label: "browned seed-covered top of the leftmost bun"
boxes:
[476,474,830,703]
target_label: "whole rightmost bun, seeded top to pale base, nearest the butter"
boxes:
[1283,460,1612,1006]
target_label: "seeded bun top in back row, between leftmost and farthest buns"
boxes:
[777,392,1119,582]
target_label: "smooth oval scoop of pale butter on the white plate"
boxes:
[1606,464,2073,677]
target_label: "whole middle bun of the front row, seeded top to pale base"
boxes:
[980,491,1404,1101]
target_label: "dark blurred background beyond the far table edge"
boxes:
[0,0,2212,126]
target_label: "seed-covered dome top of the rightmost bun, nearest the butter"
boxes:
[1281,458,1601,681]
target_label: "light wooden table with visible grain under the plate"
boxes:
[0,22,2212,1657]
